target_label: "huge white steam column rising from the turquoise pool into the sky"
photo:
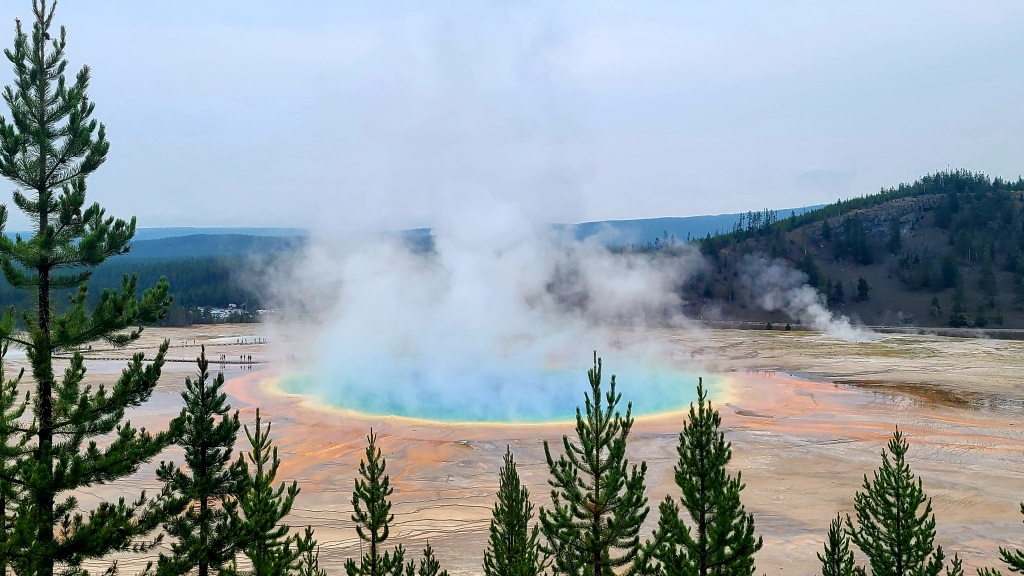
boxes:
[245,4,864,419]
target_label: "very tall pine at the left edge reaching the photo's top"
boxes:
[0,0,171,576]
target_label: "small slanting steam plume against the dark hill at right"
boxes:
[741,256,877,342]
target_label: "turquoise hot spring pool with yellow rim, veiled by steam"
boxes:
[280,362,722,423]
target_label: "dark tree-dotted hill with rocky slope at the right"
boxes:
[688,170,1024,328]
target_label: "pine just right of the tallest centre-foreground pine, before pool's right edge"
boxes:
[654,379,762,576]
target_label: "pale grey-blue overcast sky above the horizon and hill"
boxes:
[0,0,1024,230]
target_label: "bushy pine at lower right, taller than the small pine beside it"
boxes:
[846,428,945,576]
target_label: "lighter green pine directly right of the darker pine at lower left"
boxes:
[230,408,302,576]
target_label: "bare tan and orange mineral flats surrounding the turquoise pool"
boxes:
[18,325,1024,575]
